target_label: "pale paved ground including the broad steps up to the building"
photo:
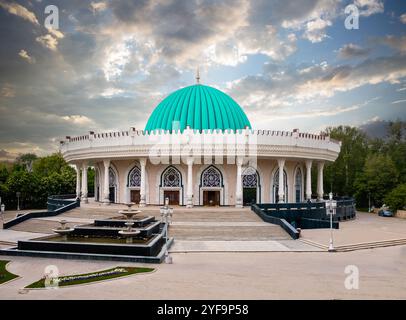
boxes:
[0,202,406,299]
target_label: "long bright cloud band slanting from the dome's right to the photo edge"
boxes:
[228,55,406,112]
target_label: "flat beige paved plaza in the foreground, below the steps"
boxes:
[0,246,406,300]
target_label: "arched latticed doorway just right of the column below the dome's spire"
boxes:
[199,165,225,205]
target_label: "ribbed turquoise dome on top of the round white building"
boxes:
[145,84,251,131]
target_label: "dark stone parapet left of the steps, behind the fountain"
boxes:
[3,195,80,229]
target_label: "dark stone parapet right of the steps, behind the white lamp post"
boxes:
[251,199,356,239]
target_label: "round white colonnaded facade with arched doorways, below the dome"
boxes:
[60,128,341,208]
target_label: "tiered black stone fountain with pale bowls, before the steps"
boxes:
[5,203,173,263]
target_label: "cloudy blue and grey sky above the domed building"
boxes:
[0,0,406,160]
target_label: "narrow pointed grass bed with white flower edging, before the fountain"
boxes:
[26,267,155,289]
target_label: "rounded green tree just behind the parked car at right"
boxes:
[354,154,399,207]
